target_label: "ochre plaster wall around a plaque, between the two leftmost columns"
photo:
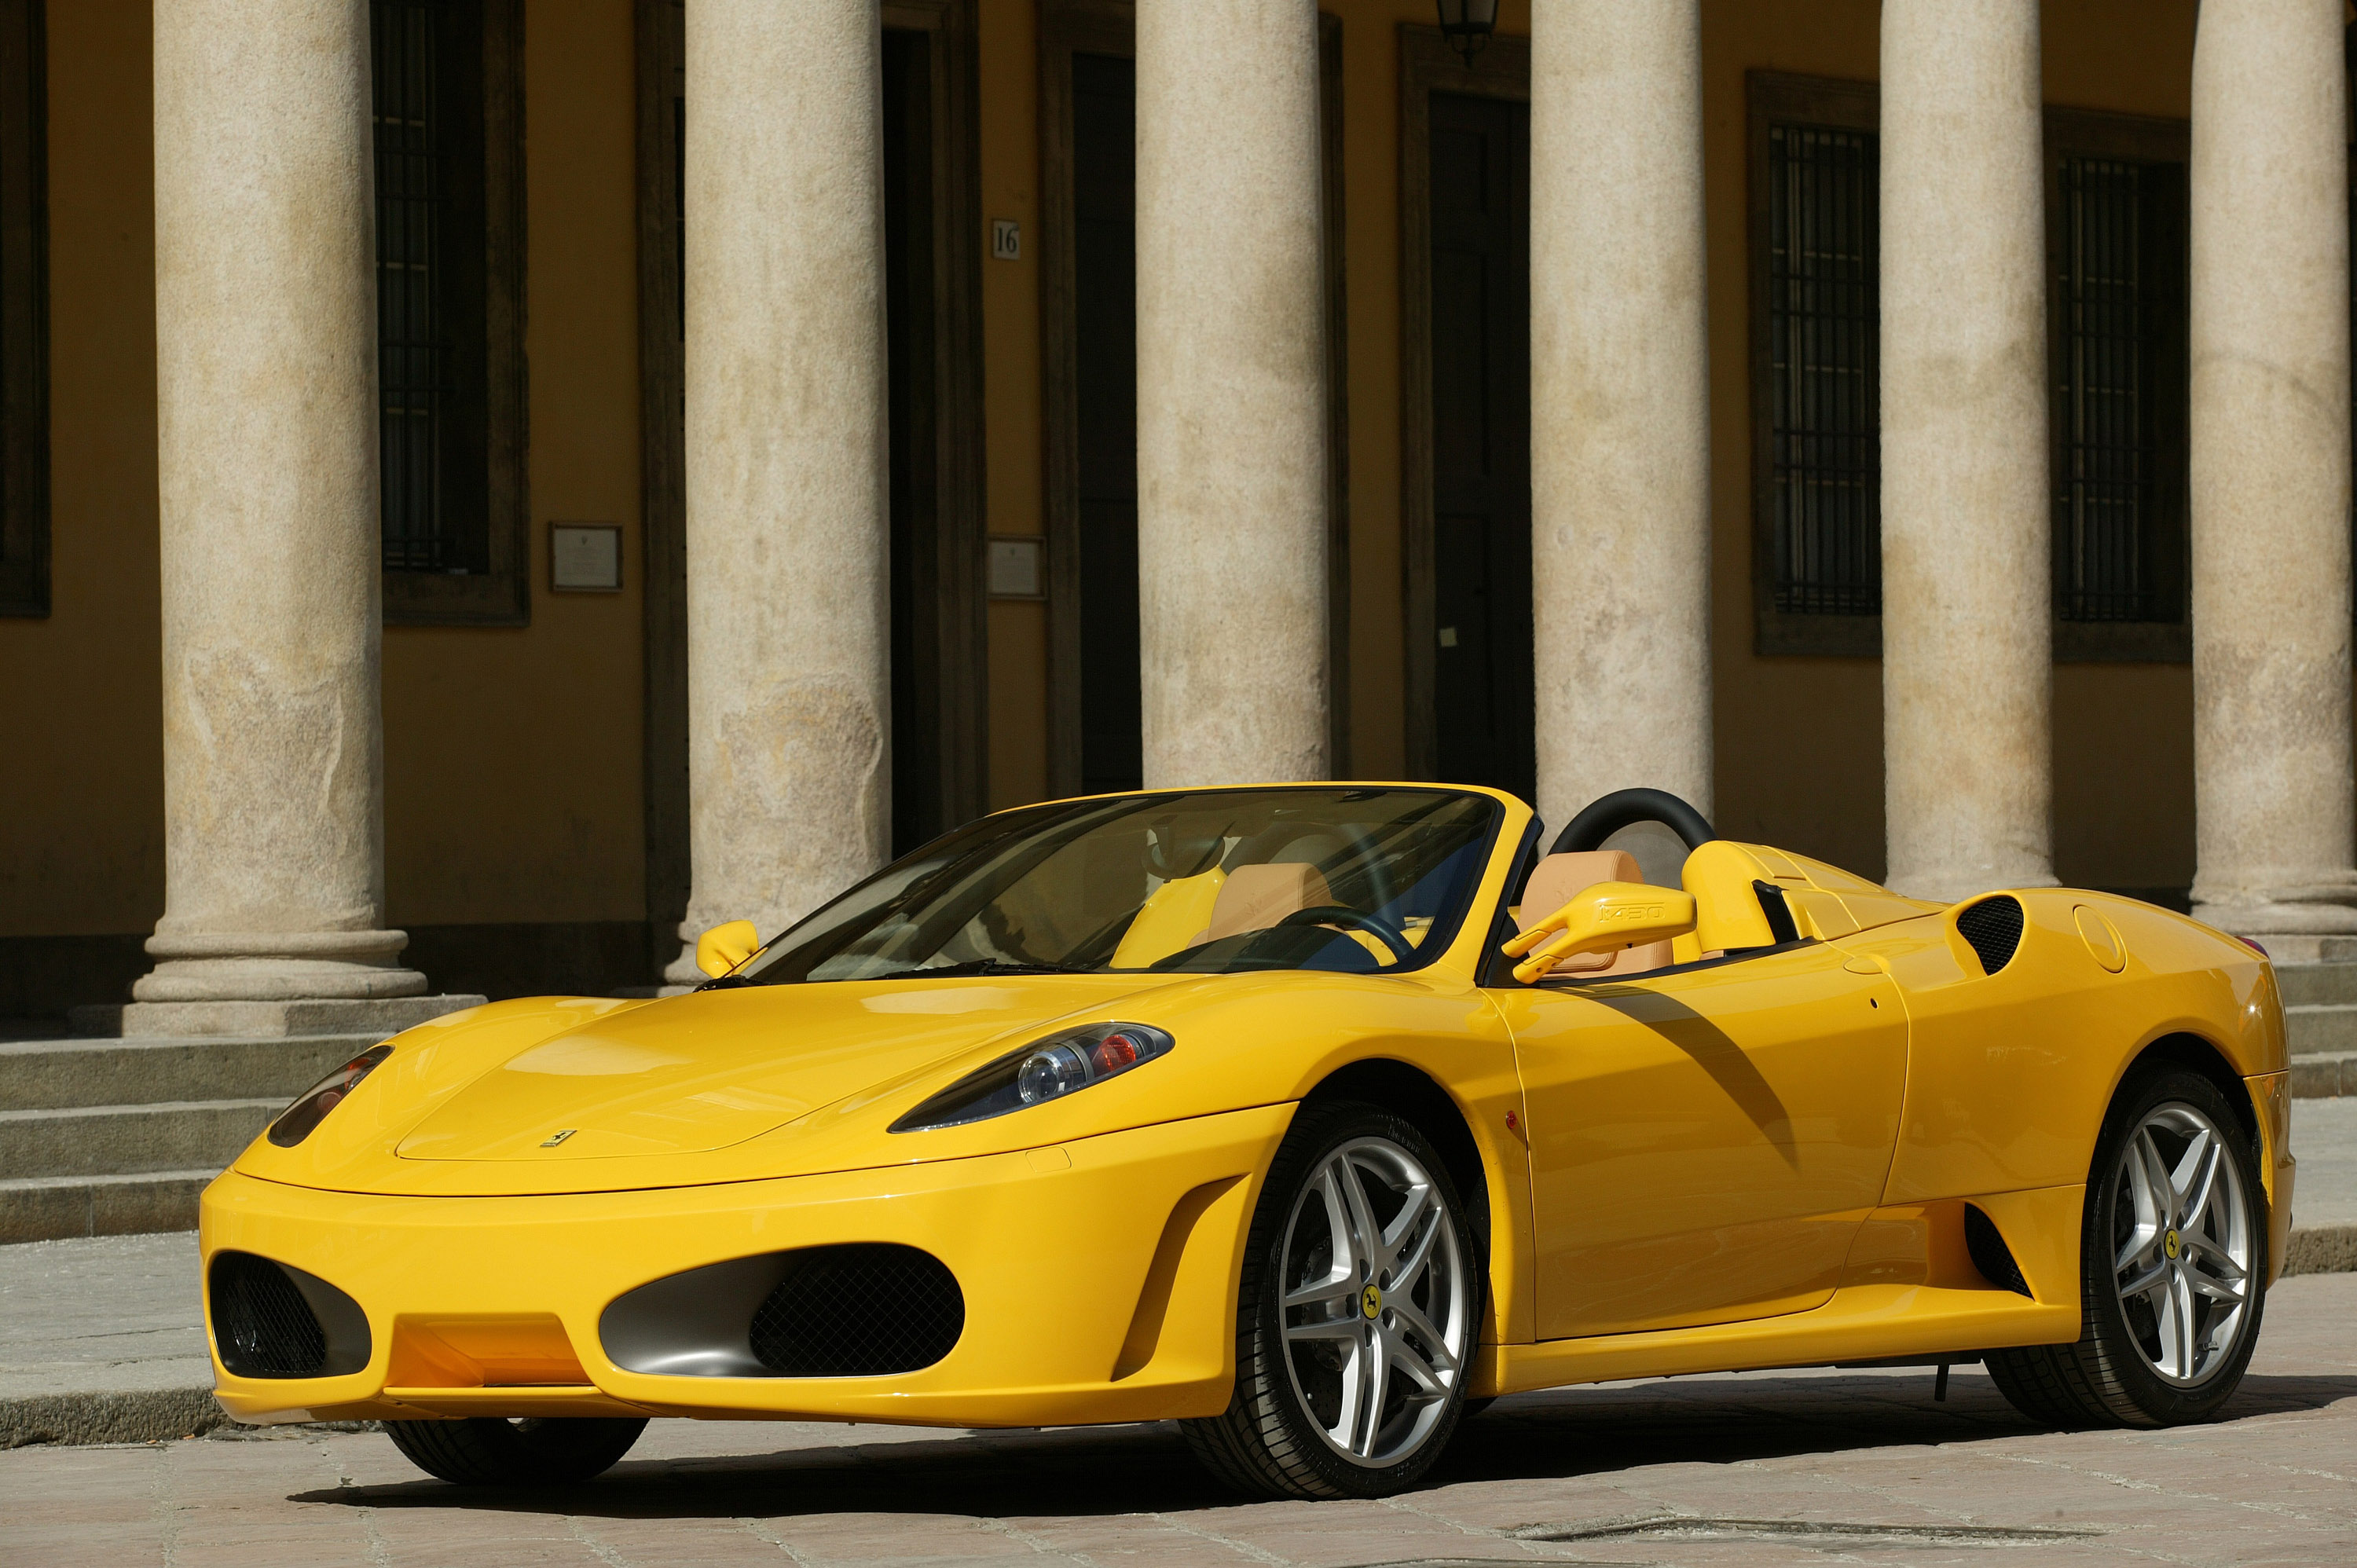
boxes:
[384,0,646,927]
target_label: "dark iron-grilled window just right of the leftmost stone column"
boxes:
[370,0,530,622]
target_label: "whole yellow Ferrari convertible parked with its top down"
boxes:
[203,782,2293,1497]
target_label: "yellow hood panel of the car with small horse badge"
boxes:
[396,979,1169,1163]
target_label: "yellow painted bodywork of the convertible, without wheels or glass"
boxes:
[203,797,2293,1427]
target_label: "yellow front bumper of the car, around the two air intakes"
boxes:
[203,1104,1294,1427]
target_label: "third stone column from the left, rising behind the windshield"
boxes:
[1136,0,1329,788]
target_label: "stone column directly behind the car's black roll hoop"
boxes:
[1530,0,1711,826]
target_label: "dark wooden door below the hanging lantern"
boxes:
[1431,94,1537,800]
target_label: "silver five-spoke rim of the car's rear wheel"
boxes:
[2112,1101,2253,1387]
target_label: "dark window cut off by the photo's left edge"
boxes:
[0,0,49,615]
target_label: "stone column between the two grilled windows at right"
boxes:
[1881,0,2053,899]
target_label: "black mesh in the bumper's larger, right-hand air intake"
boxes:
[752,1243,966,1377]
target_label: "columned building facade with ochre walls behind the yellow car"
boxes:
[0,0,2357,1017]
